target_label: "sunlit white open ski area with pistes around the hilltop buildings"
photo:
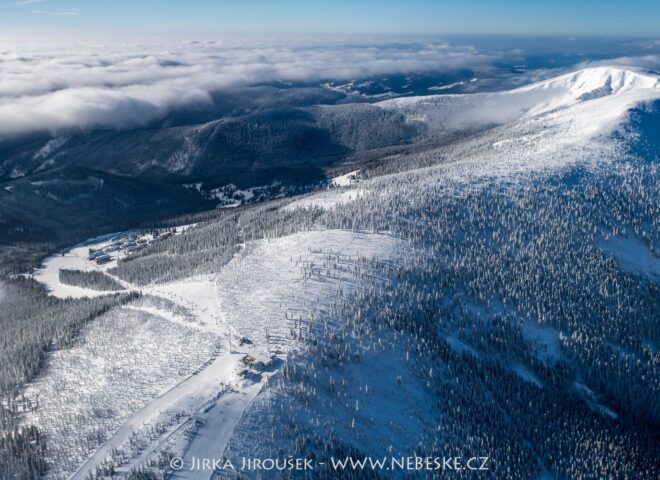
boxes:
[25,230,407,480]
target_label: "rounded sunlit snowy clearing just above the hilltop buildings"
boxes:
[217,230,406,356]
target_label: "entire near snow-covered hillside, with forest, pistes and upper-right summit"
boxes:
[10,67,660,480]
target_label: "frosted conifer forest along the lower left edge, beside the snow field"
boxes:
[0,277,135,479]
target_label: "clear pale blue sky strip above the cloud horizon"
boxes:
[0,0,660,38]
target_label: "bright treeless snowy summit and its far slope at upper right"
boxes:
[377,67,660,134]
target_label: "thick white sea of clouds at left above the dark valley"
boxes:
[0,41,495,138]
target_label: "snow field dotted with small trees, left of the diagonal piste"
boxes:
[24,308,216,478]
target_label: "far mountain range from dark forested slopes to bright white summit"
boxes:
[0,67,660,246]
